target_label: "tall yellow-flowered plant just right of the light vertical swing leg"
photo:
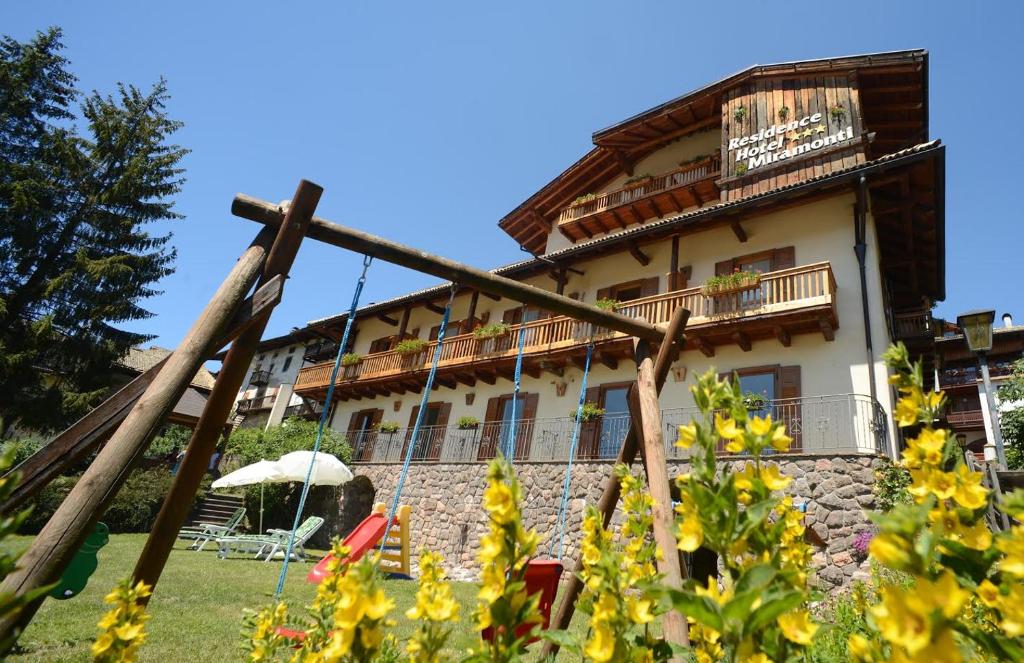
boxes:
[667,371,818,662]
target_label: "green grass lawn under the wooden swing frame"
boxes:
[8,534,589,663]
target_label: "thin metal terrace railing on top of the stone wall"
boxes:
[347,393,888,463]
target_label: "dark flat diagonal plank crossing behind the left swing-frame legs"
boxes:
[0,279,284,513]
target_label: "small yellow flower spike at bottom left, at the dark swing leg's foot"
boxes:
[92,578,151,663]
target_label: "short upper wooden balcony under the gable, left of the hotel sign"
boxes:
[558,156,722,242]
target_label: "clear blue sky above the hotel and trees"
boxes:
[6,0,1024,346]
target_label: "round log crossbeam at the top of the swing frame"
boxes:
[231,194,665,342]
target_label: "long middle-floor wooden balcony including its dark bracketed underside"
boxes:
[295,262,839,401]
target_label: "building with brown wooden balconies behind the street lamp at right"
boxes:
[934,315,1024,459]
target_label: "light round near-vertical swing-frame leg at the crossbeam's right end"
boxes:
[629,341,690,646]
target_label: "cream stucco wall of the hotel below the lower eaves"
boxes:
[321,194,892,457]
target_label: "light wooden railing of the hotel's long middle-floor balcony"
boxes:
[295,262,836,391]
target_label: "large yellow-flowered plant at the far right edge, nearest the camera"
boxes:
[849,343,1024,662]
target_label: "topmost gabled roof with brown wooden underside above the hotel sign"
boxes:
[498,49,928,254]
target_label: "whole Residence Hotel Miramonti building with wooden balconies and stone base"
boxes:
[228,50,945,584]
